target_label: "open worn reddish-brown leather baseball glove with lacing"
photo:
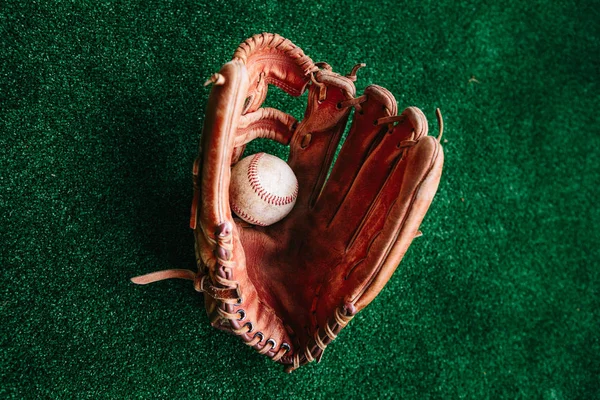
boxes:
[132,33,444,372]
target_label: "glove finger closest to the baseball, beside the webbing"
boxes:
[288,70,355,212]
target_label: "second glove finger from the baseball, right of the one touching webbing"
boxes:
[314,85,397,226]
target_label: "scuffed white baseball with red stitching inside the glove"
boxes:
[229,153,298,226]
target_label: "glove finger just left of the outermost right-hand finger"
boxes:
[328,107,427,247]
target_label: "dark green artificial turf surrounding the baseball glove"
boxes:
[0,0,600,399]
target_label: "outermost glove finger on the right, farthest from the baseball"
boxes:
[317,137,444,321]
